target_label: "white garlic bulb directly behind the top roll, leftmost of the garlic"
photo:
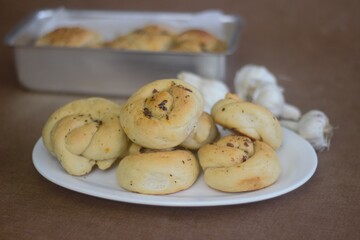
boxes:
[178,72,229,113]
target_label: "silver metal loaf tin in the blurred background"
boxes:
[5,8,243,96]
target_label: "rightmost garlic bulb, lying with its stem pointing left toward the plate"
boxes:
[280,110,333,152]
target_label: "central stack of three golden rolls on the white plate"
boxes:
[116,79,218,194]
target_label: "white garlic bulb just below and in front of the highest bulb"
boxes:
[252,84,285,117]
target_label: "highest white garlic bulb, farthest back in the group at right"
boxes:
[234,64,277,101]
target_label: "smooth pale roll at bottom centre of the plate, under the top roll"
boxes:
[116,150,200,195]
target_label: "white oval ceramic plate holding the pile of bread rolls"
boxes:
[33,129,317,206]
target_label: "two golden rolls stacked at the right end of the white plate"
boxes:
[198,93,282,192]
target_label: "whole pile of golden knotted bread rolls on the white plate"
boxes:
[43,79,282,194]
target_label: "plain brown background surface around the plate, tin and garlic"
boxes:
[0,0,360,240]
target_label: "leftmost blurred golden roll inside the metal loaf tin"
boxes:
[35,27,102,47]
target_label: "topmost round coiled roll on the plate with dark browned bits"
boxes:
[120,79,204,149]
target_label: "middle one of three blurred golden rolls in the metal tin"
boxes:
[105,25,174,51]
